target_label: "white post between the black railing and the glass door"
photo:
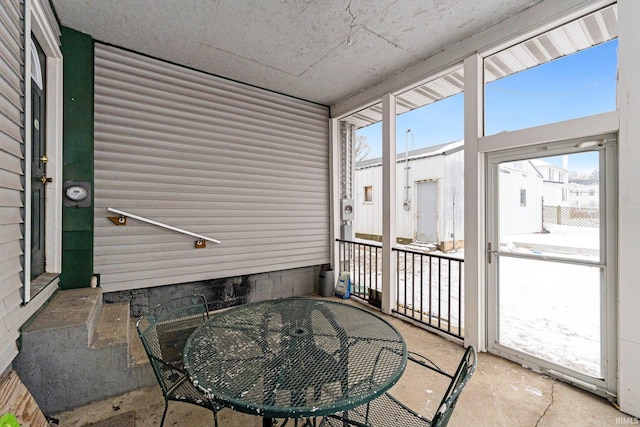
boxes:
[464,55,486,350]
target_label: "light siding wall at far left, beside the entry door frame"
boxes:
[0,1,24,372]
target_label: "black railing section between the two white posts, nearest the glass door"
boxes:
[393,248,464,338]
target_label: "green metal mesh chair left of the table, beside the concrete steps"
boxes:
[136,295,220,427]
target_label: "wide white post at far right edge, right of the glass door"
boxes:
[617,0,640,417]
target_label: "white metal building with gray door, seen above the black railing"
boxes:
[353,141,464,250]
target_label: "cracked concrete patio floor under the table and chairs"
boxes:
[53,301,638,427]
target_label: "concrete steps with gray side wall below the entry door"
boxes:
[14,288,157,414]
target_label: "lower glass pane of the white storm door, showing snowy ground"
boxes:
[498,257,602,378]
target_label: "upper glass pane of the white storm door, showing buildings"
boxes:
[498,151,600,262]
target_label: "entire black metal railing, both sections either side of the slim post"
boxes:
[337,239,464,338]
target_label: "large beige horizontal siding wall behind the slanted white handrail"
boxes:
[94,44,329,292]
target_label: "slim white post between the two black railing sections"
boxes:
[382,94,396,313]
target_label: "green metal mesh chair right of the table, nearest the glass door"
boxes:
[323,346,478,427]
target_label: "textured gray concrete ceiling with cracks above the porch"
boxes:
[52,0,541,105]
